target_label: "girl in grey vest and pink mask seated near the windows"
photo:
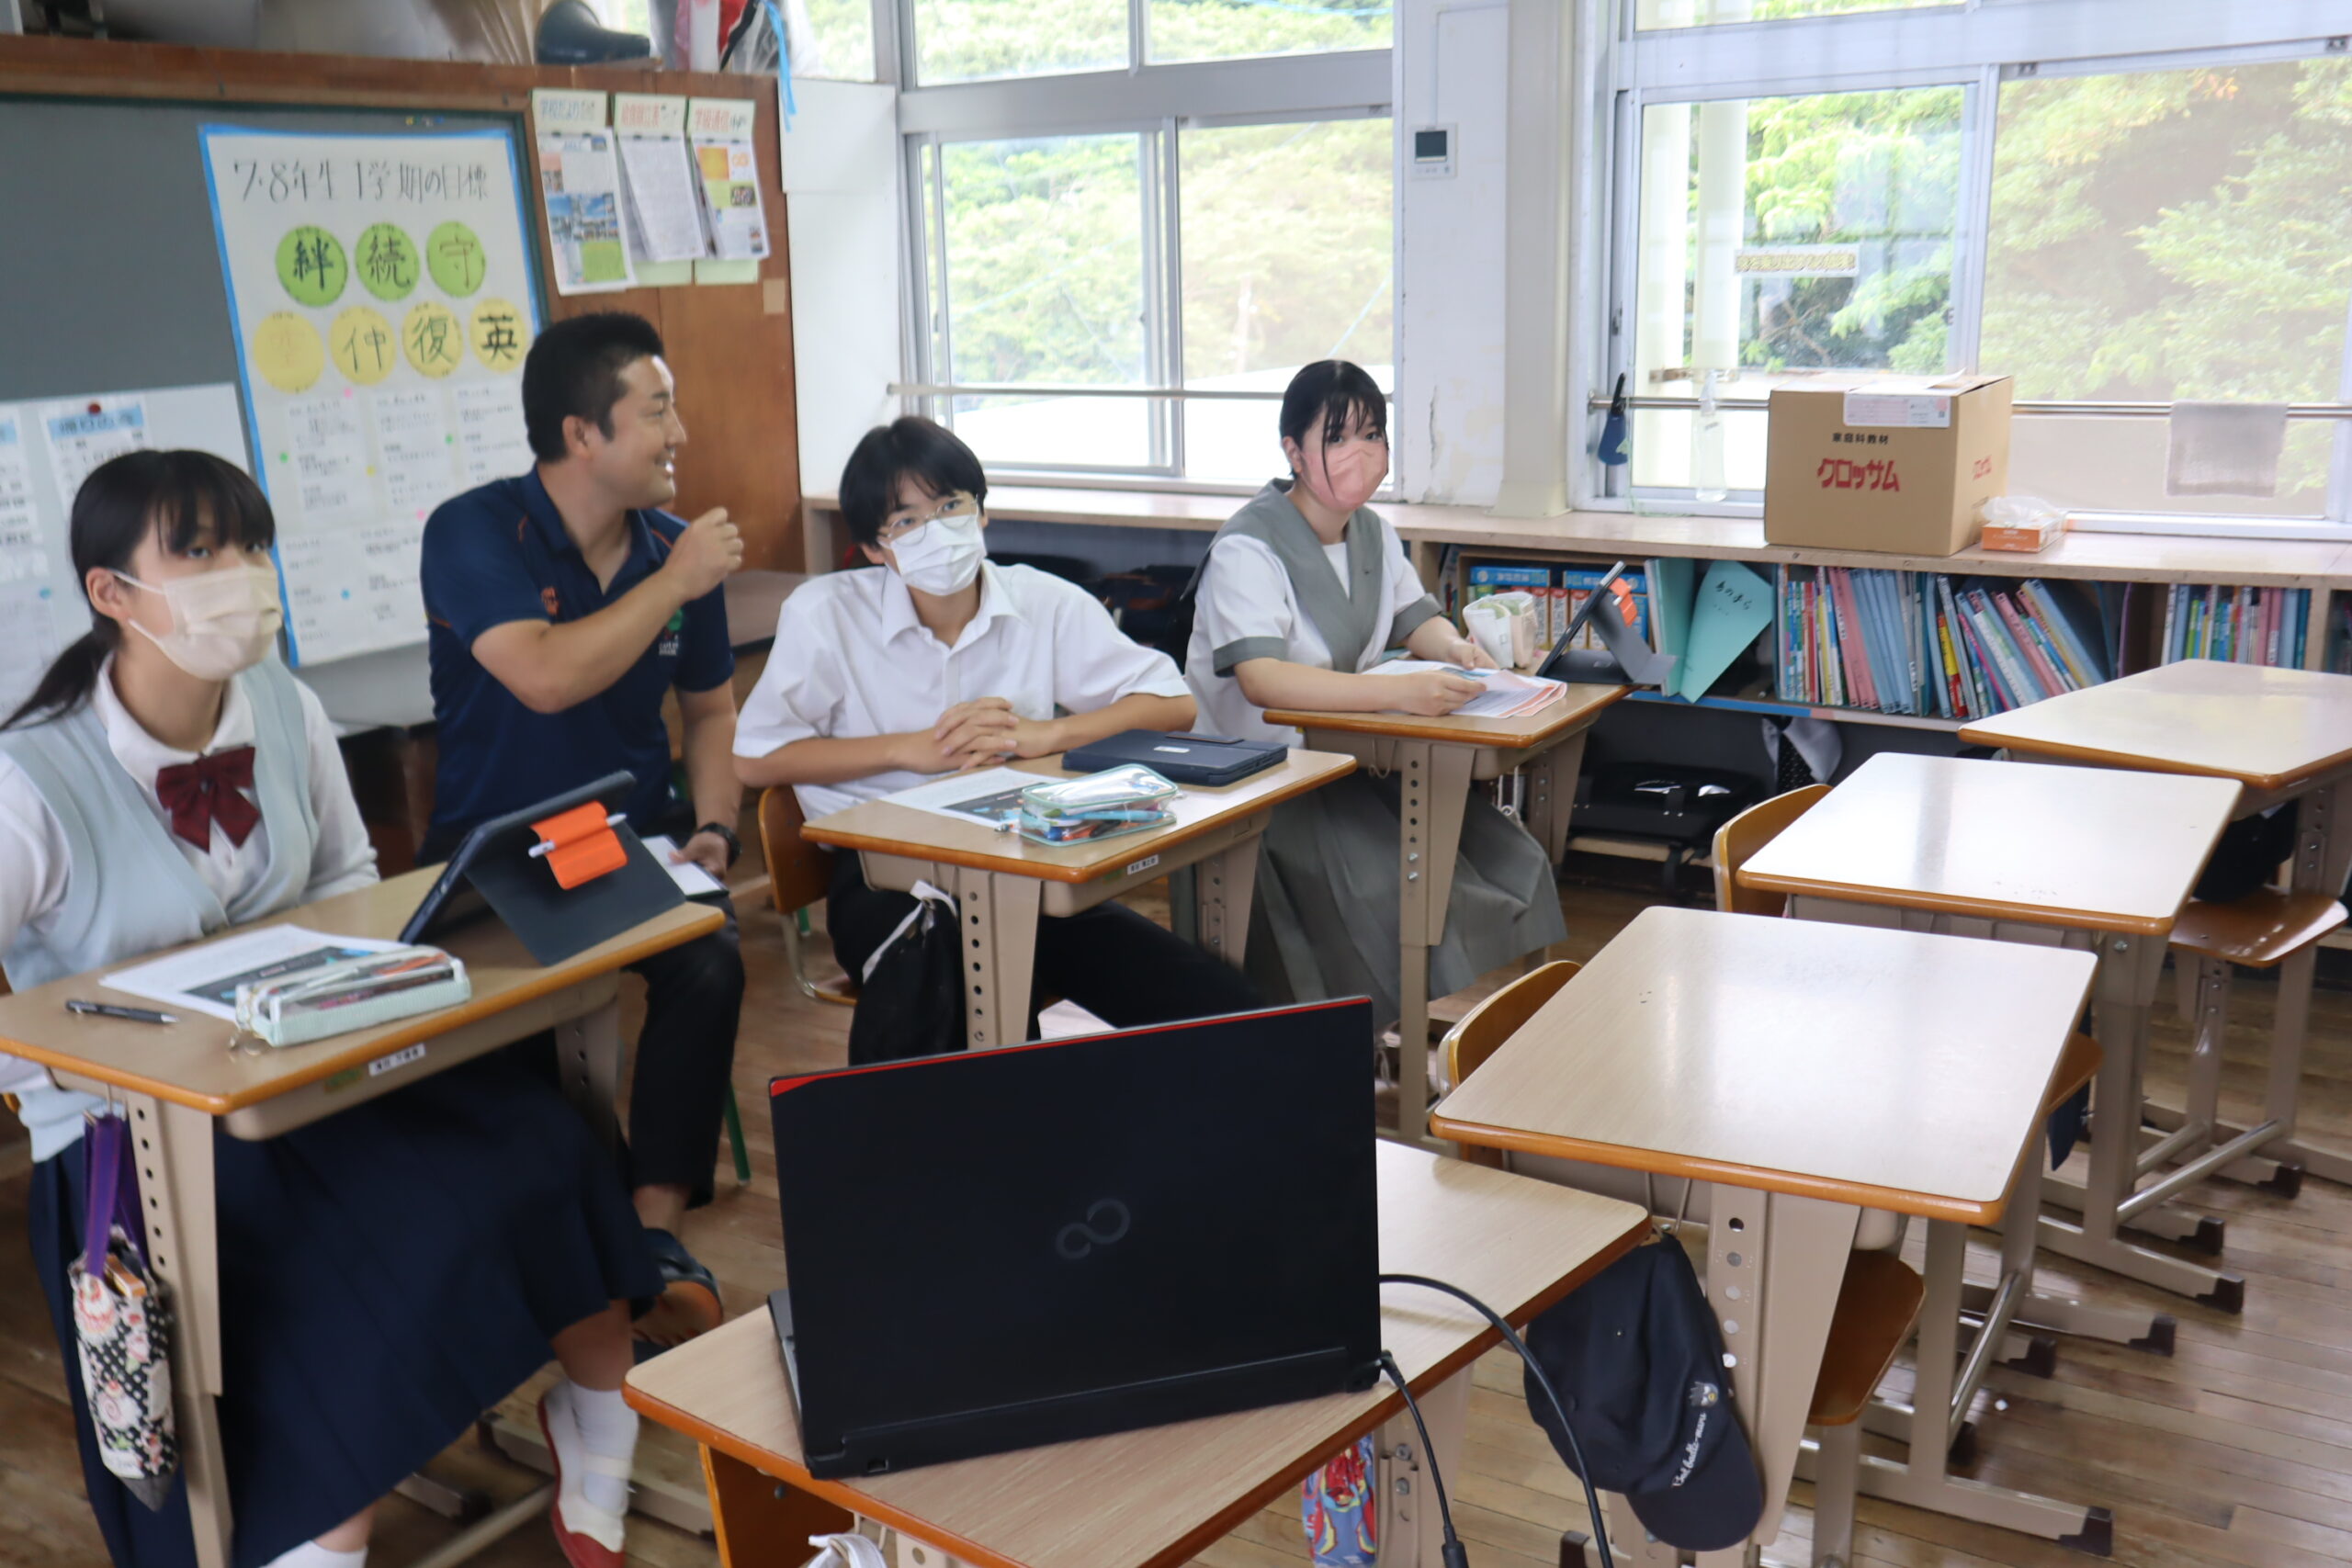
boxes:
[1185,360,1566,1021]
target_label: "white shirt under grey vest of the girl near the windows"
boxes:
[1185,505,1430,745]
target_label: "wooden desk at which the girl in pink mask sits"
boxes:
[1265,684,1628,1143]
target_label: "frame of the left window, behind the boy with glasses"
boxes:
[877,0,1399,493]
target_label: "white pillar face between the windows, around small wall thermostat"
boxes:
[1393,0,1510,505]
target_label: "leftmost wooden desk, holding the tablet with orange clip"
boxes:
[0,867,724,1568]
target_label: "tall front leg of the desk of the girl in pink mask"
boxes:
[1397,740,1470,1152]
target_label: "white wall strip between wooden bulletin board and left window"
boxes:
[783,80,906,502]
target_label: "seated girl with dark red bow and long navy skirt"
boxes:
[0,451,661,1568]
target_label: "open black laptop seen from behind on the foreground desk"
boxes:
[769,999,1381,1476]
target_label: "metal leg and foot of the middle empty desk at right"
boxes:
[2041,936,2246,1312]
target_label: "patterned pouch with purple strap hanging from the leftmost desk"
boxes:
[66,1117,179,1509]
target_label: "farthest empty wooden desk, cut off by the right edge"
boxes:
[1959,659,2352,1182]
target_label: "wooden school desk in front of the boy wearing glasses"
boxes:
[802,750,1355,1051]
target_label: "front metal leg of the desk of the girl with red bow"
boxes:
[125,1096,235,1568]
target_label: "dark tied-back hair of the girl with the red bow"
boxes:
[0,451,277,728]
